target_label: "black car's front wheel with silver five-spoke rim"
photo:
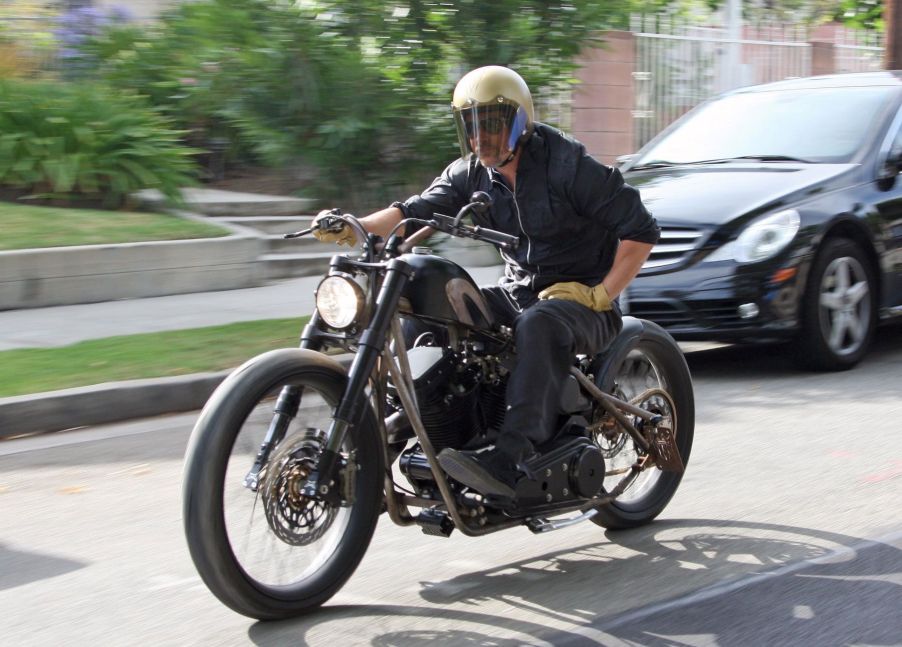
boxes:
[797,238,877,371]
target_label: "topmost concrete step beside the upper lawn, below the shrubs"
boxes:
[135,187,317,218]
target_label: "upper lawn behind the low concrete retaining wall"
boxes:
[0,202,229,250]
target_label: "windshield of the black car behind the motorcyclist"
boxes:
[633,87,895,168]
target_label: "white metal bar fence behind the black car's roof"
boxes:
[632,16,883,150]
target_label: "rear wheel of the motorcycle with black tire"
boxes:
[592,321,695,530]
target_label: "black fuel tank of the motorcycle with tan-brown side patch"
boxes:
[401,253,494,330]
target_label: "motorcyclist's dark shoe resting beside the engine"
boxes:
[438,447,531,499]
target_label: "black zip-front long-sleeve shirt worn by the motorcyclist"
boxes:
[401,123,660,294]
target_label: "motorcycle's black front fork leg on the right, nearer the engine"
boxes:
[317,258,413,493]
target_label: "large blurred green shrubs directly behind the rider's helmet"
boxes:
[77,0,632,204]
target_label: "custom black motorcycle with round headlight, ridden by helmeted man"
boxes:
[183,194,695,619]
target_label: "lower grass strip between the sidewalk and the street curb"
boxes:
[0,317,309,397]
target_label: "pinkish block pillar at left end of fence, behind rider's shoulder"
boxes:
[571,31,636,164]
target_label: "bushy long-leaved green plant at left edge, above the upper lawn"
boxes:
[0,81,195,207]
